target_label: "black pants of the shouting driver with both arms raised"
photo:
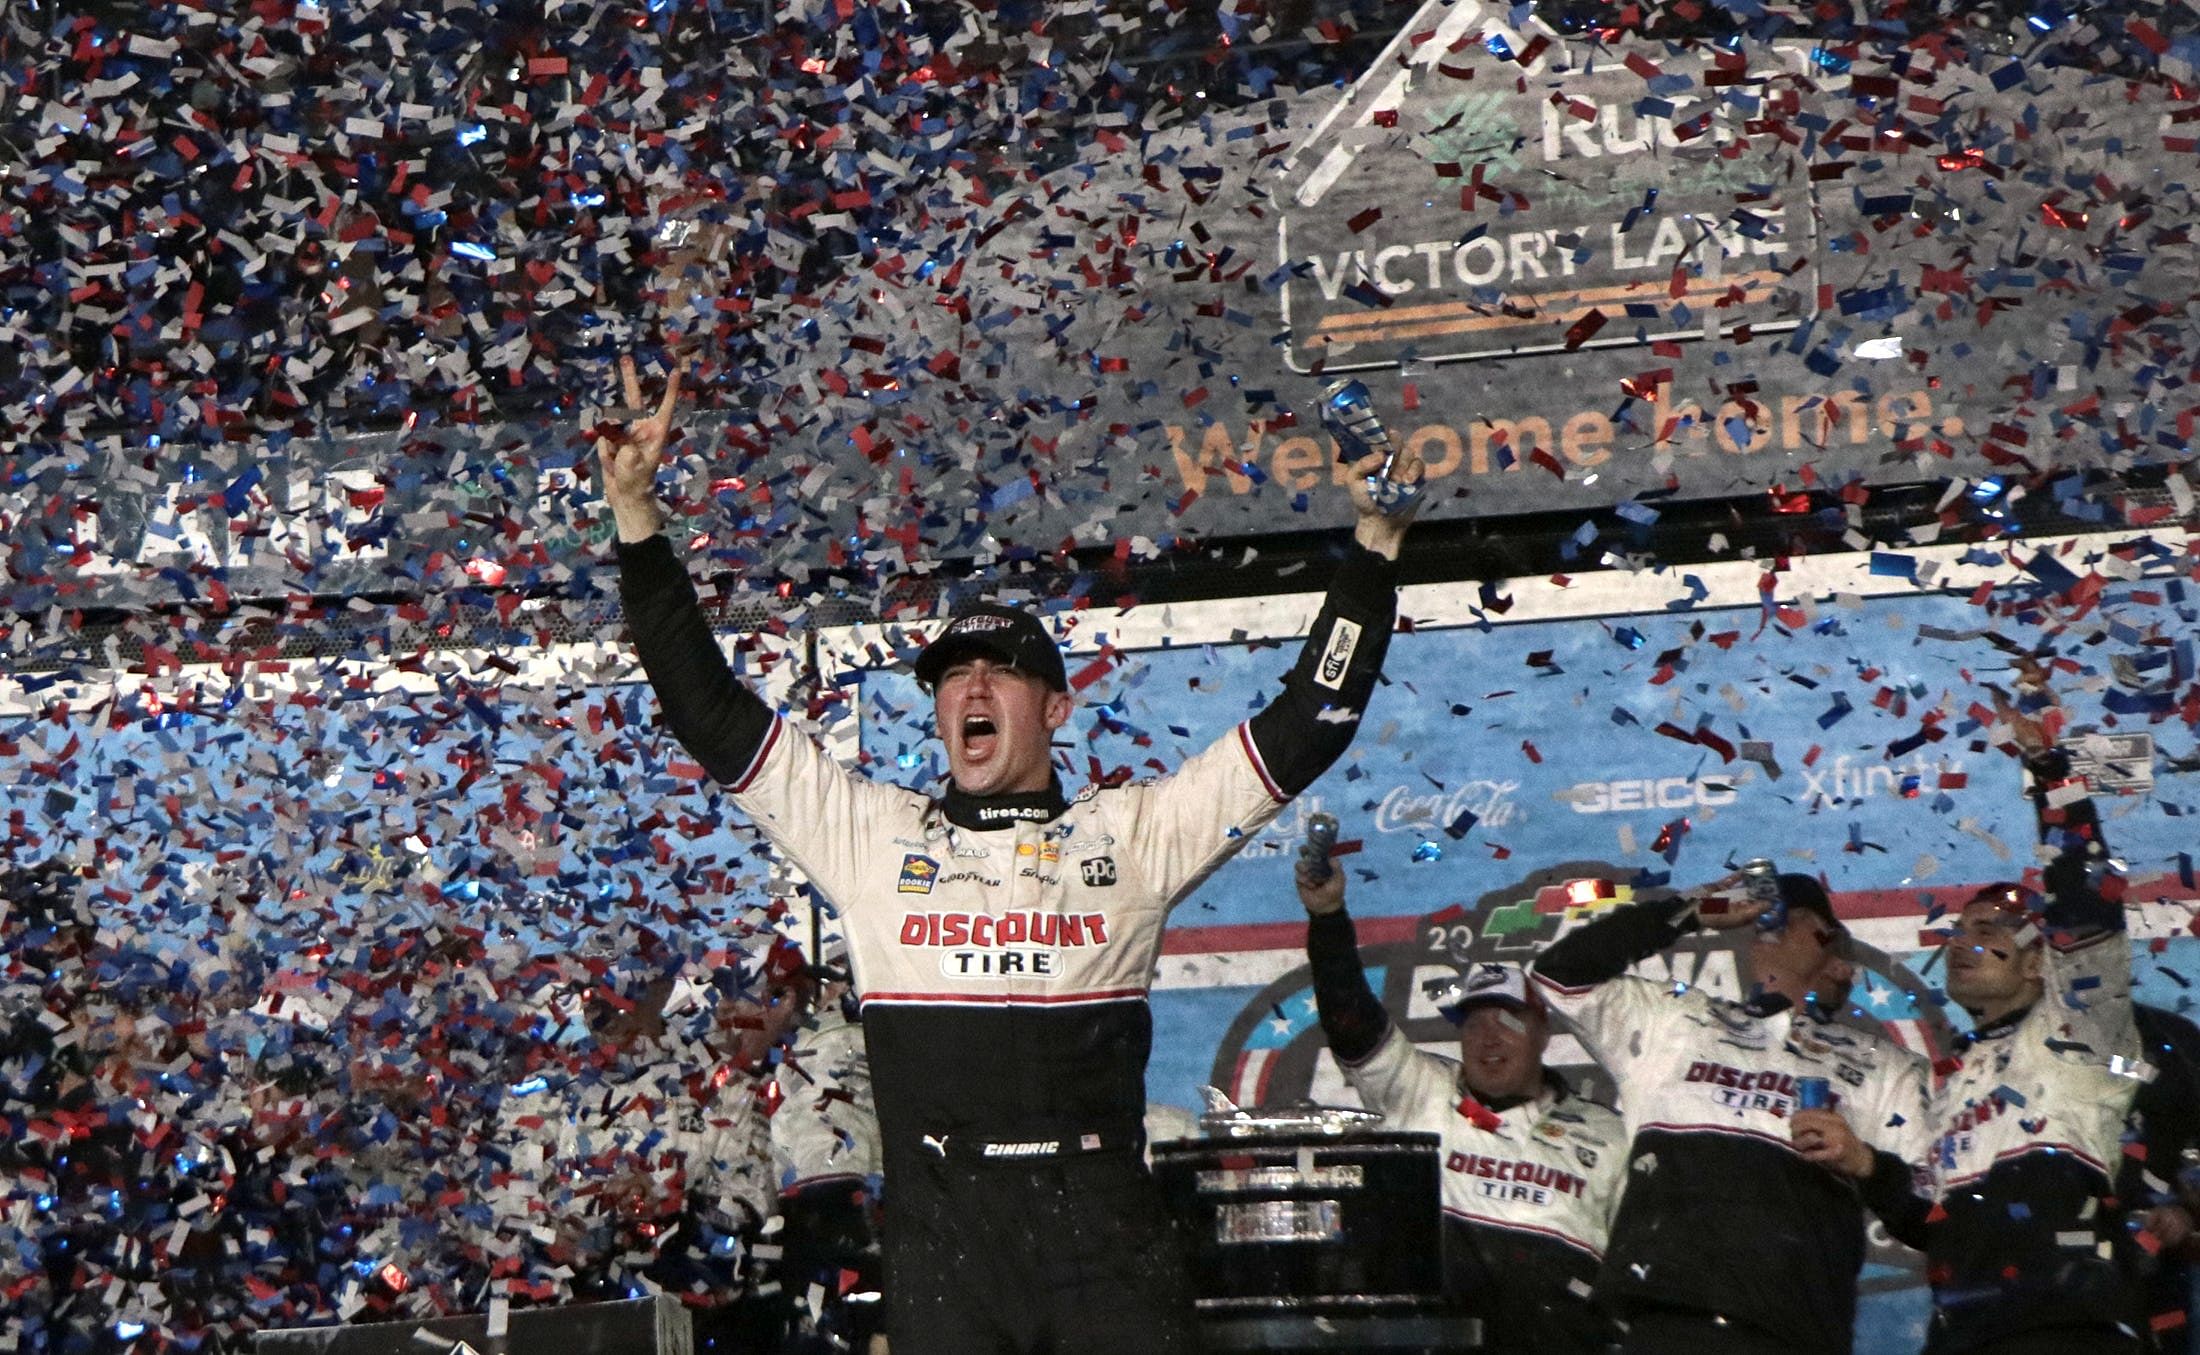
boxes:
[880,1153,1197,1355]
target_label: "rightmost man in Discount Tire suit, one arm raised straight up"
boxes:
[1795,721,2138,1355]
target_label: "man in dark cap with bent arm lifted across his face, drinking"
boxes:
[1536,875,1925,1355]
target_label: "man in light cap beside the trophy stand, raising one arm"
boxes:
[1298,860,1626,1355]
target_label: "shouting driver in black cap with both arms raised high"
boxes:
[596,361,1421,1355]
